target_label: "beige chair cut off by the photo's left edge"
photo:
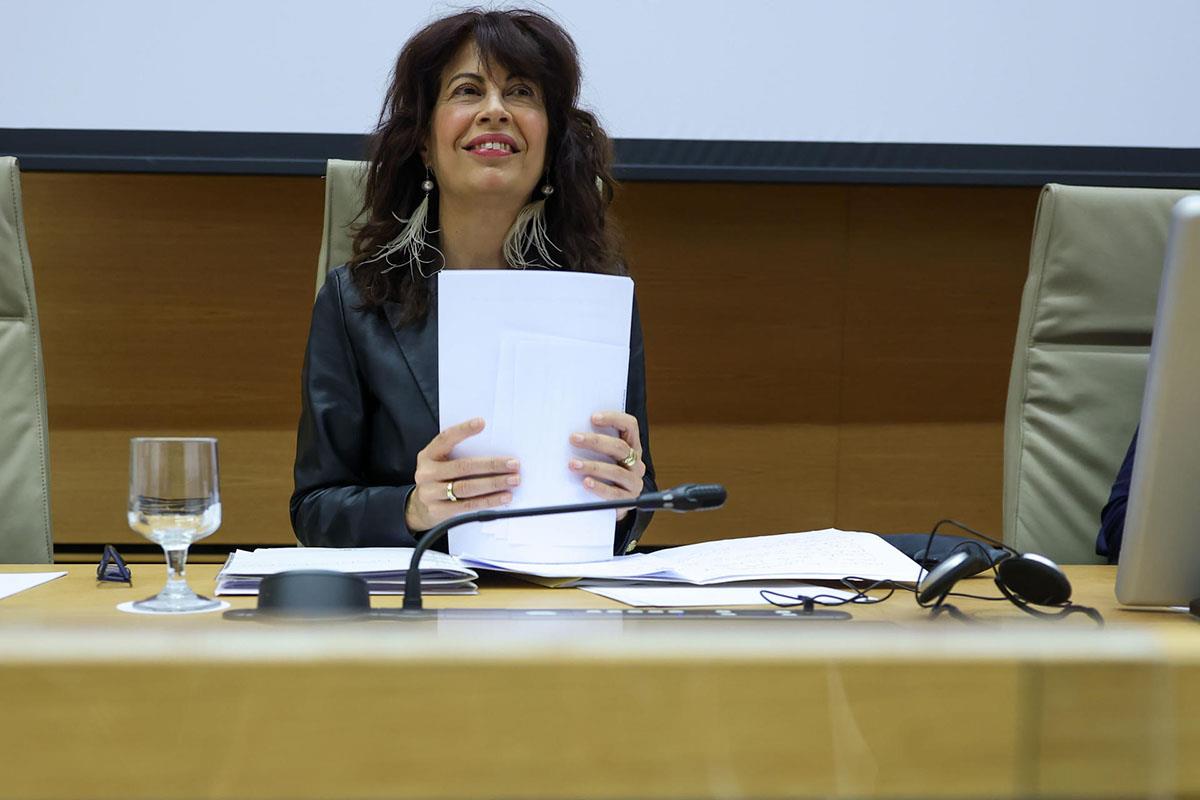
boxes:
[0,157,53,564]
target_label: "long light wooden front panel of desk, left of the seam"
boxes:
[0,656,1032,800]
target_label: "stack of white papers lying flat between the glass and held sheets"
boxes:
[216,547,479,595]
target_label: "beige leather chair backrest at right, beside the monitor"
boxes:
[1004,184,1194,564]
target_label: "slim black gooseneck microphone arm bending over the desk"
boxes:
[403,483,726,612]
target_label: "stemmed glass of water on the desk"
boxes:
[128,437,221,613]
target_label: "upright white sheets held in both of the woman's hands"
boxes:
[438,270,634,563]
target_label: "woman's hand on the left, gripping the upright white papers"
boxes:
[404,417,521,531]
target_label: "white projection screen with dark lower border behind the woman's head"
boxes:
[0,0,1200,186]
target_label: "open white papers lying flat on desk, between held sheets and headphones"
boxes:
[460,528,920,585]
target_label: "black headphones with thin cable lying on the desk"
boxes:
[917,519,1104,625]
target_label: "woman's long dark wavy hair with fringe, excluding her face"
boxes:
[349,10,625,323]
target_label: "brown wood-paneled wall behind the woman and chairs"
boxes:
[14,173,1037,545]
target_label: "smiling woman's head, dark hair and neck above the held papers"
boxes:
[350,11,624,320]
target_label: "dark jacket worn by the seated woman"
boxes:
[290,266,656,554]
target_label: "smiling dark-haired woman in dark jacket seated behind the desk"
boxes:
[290,11,655,554]
